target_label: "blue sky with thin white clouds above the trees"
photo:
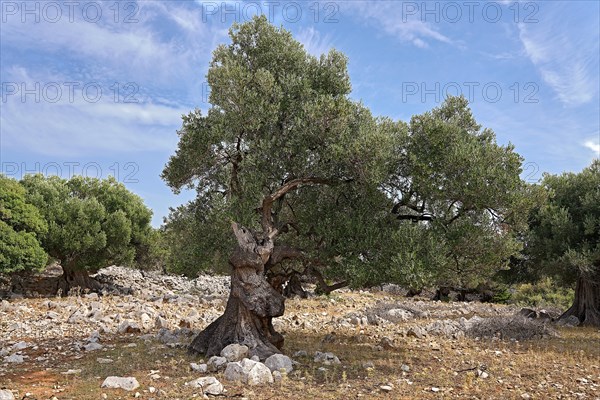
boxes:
[0,0,600,226]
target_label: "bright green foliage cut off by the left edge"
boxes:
[0,175,48,273]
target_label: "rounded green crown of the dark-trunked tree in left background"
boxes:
[21,175,152,271]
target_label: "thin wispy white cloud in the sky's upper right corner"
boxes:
[518,2,600,106]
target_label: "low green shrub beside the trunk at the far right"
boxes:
[510,277,575,310]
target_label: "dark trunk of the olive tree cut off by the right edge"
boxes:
[559,267,600,327]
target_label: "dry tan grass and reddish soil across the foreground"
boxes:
[0,293,600,400]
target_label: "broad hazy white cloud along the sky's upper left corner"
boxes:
[2,2,216,84]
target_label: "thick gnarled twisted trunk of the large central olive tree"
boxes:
[189,223,285,360]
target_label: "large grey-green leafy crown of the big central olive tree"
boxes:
[162,17,535,288]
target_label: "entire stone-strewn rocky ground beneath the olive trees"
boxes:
[0,267,600,400]
